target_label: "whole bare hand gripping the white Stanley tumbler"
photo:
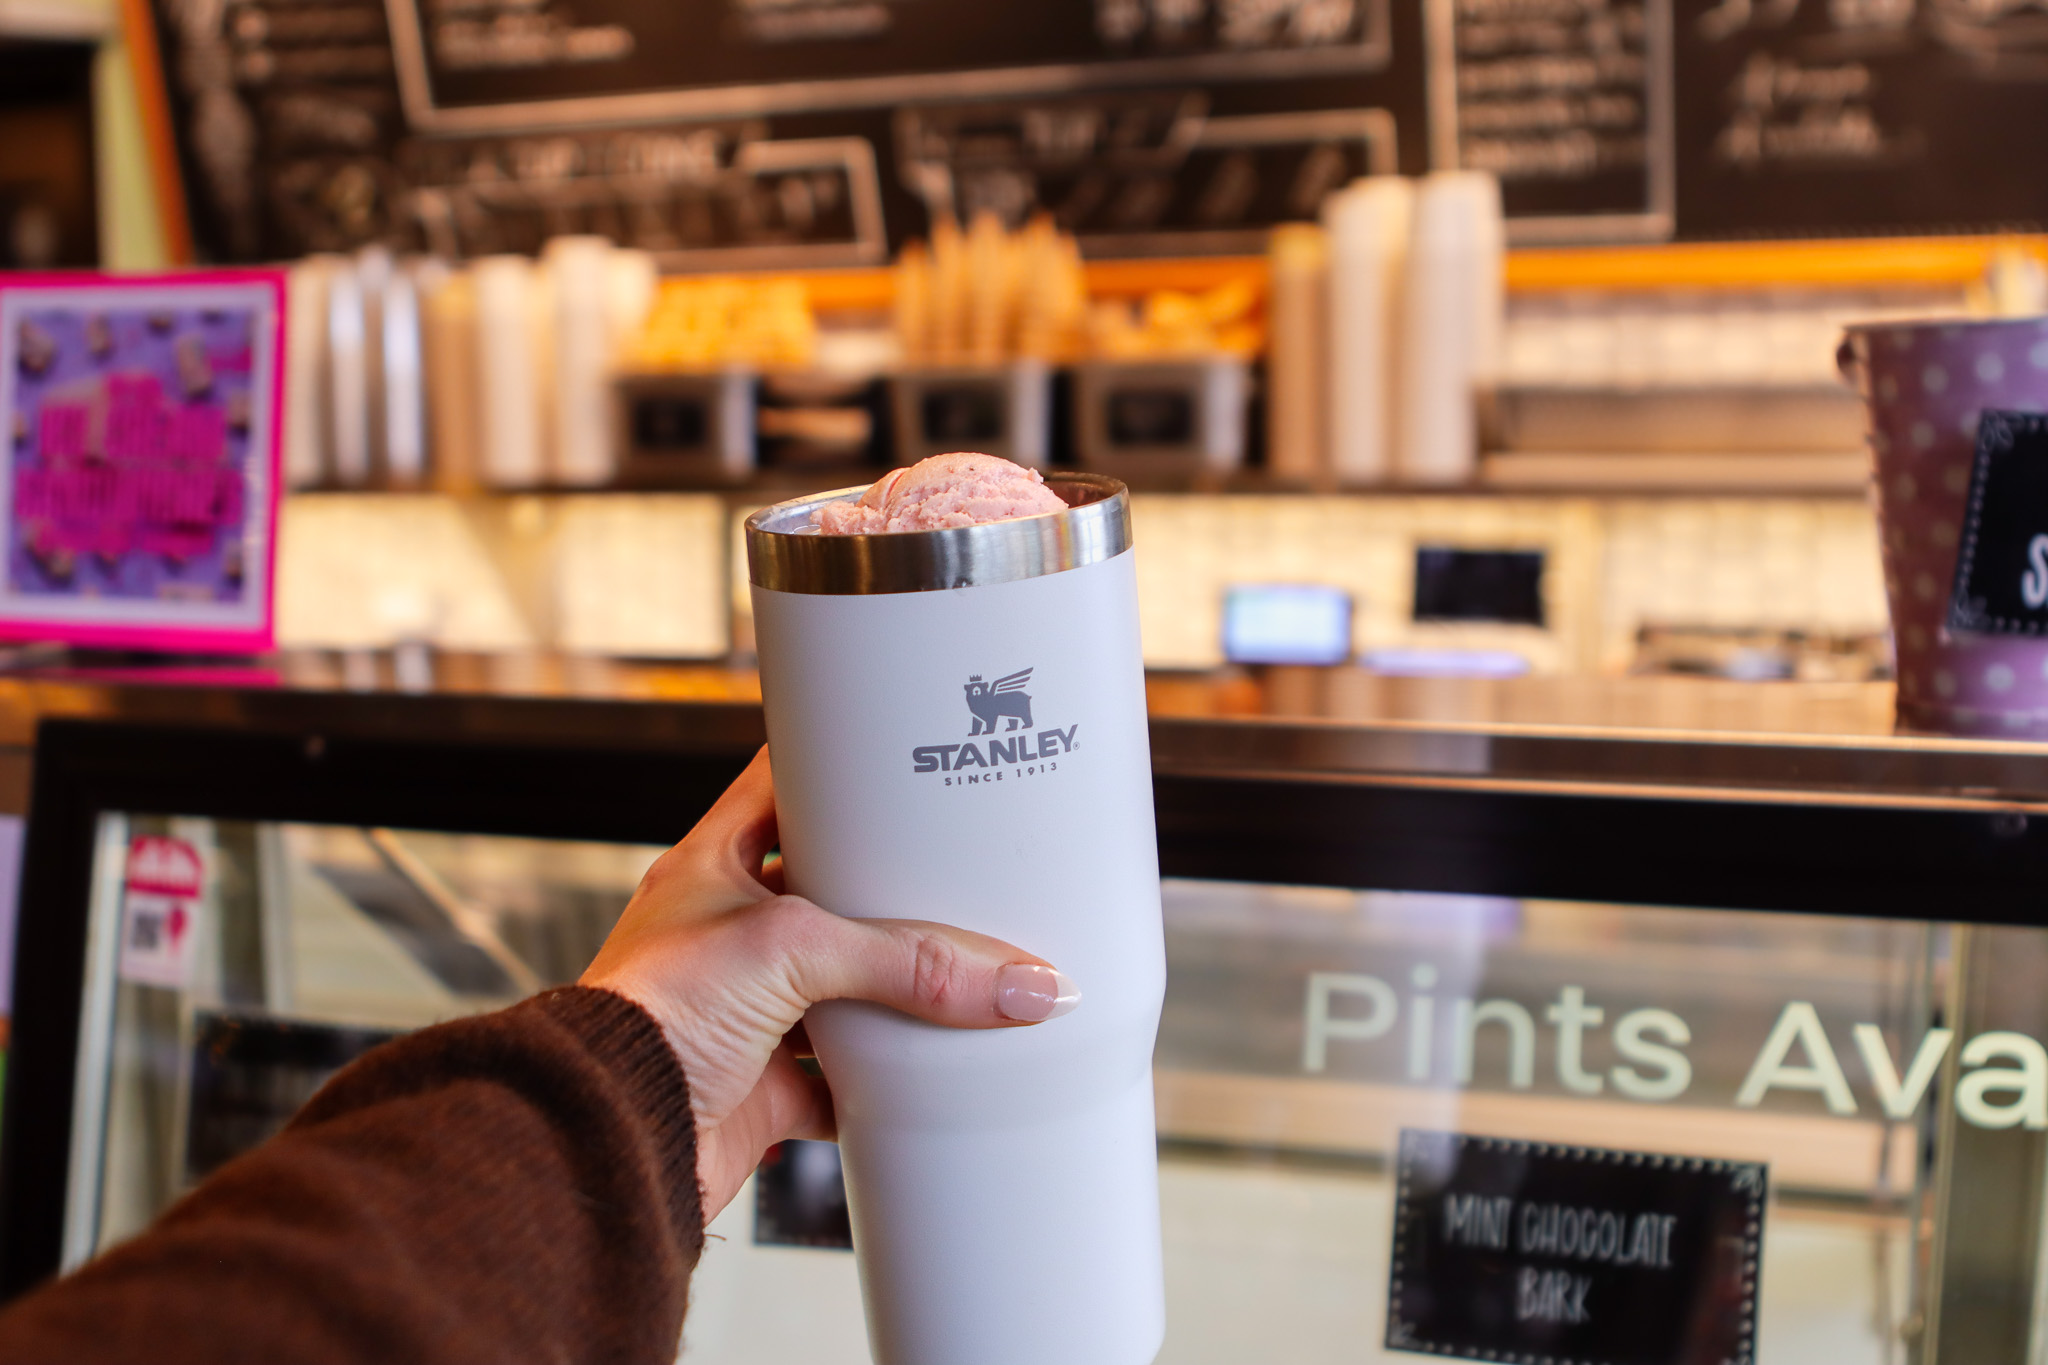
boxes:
[582,749,1081,1220]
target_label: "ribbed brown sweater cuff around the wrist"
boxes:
[528,986,705,1265]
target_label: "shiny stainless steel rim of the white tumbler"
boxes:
[748,471,1130,596]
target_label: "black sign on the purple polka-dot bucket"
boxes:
[1948,409,2048,634]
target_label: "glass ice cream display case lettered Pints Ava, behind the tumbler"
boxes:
[0,669,2048,1365]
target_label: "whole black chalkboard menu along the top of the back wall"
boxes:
[152,0,2048,268]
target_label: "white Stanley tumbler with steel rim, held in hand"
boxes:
[748,473,1165,1365]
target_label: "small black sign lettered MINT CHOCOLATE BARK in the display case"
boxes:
[1386,1128,1767,1365]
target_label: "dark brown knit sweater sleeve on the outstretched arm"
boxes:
[0,986,705,1365]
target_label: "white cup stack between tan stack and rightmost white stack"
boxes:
[1323,176,1415,483]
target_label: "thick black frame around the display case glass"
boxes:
[0,716,2048,1300]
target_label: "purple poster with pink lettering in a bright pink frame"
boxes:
[0,270,285,653]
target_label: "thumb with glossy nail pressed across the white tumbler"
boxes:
[788,896,1081,1029]
